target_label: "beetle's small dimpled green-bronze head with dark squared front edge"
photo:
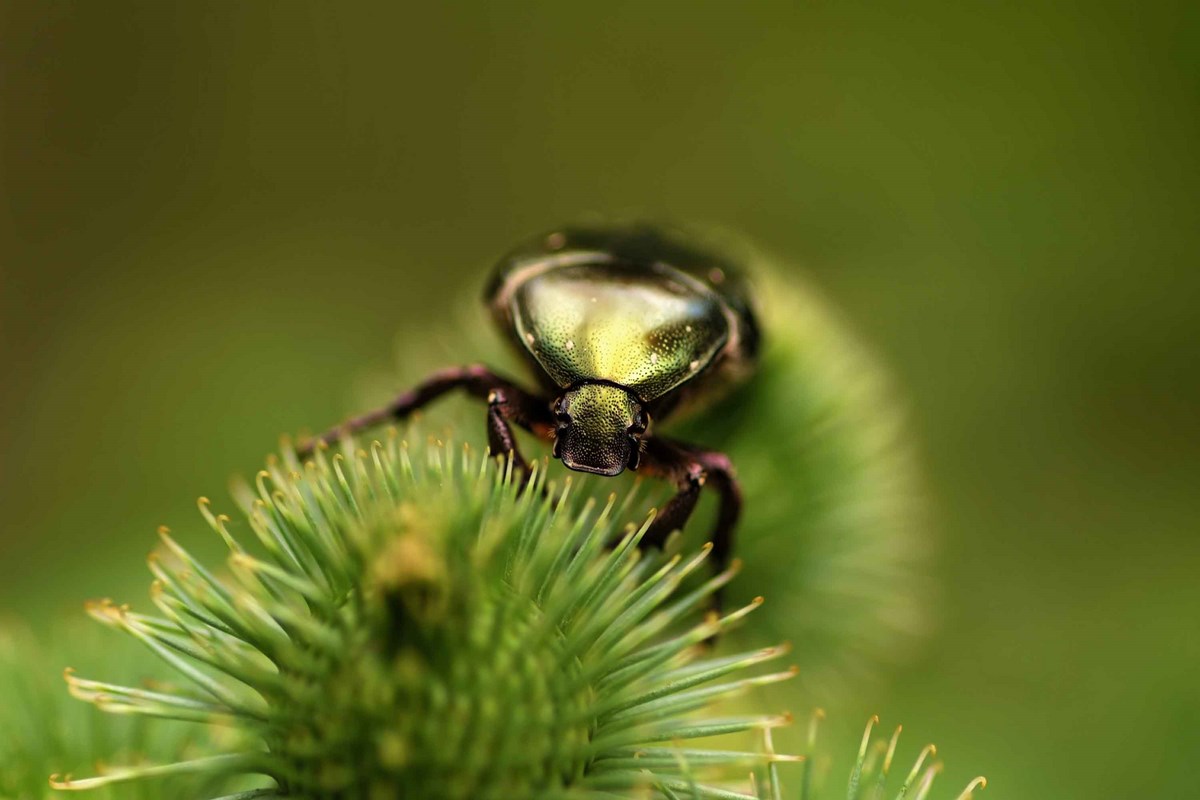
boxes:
[554,384,648,476]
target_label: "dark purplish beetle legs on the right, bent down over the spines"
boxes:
[640,438,742,587]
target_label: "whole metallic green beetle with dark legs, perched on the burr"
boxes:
[301,227,758,569]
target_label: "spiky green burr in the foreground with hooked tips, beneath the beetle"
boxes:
[56,435,792,800]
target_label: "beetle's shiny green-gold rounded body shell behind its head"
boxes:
[488,228,757,403]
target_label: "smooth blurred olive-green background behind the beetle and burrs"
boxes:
[0,1,1200,800]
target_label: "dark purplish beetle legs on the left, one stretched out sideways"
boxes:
[296,365,553,477]
